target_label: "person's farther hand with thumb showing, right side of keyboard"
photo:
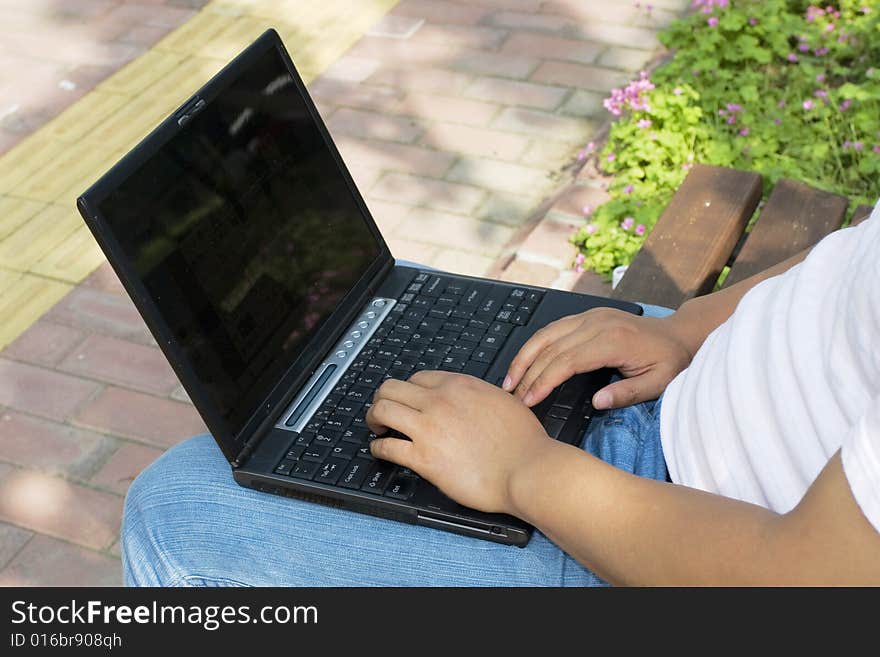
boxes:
[502,308,693,410]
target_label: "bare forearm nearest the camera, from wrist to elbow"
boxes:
[511,442,781,585]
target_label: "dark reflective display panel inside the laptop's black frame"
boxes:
[100,44,380,434]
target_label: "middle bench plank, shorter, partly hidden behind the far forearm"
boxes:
[723,179,849,287]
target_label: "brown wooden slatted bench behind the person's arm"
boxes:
[613,165,871,308]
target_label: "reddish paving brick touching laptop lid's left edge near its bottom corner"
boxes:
[74,387,207,448]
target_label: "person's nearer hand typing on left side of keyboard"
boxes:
[367,371,557,513]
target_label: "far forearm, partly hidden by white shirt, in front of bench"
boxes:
[669,249,810,357]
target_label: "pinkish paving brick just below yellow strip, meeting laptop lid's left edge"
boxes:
[46,286,154,344]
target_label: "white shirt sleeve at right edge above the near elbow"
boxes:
[841,398,880,532]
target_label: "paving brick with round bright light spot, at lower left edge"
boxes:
[0,469,122,550]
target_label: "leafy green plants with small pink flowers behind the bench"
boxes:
[572,0,880,276]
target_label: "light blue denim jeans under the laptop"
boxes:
[122,306,671,586]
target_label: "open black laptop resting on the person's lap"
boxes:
[77,30,641,546]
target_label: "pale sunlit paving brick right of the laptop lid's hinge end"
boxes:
[395,208,513,255]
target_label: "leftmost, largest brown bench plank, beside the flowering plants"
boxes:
[613,164,761,308]
